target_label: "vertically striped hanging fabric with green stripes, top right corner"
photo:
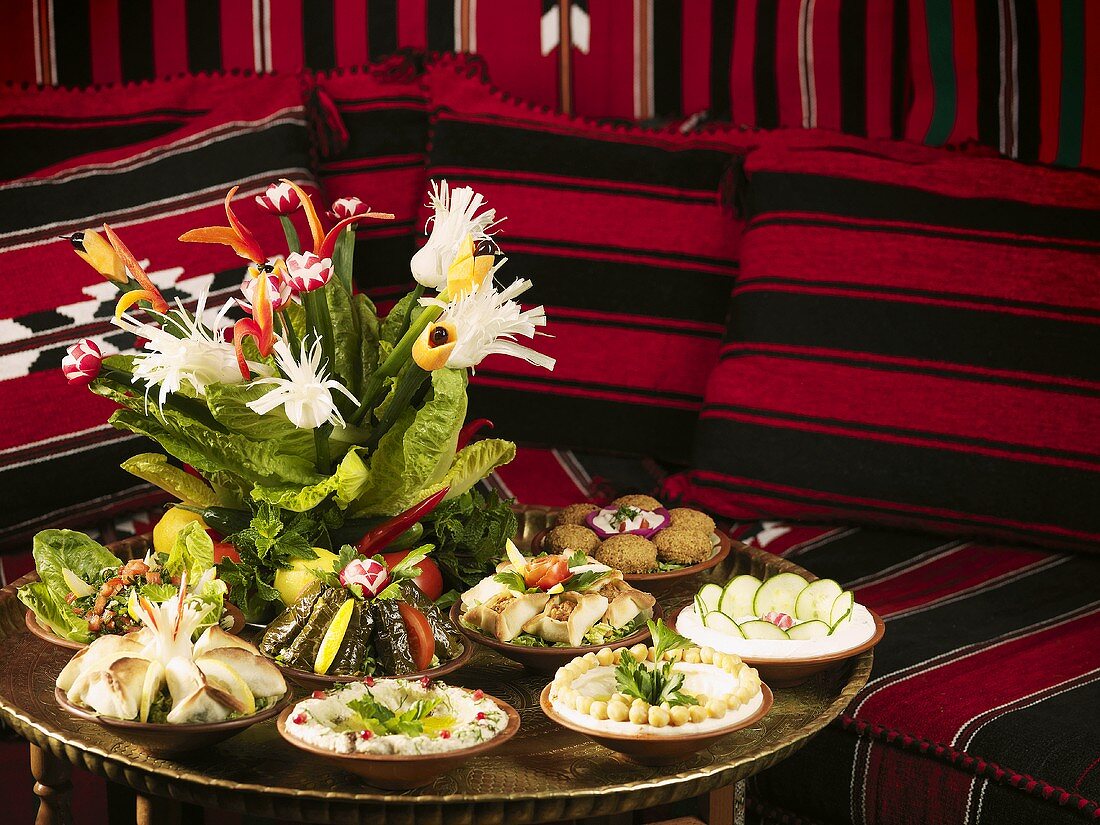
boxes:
[905,0,1100,168]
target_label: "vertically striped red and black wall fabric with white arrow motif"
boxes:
[0,0,909,129]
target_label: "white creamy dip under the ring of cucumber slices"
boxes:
[677,604,875,660]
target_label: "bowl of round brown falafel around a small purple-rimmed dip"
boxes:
[532,495,730,592]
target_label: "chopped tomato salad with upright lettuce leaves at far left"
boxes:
[18,523,227,644]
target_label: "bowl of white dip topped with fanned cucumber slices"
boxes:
[672,573,884,686]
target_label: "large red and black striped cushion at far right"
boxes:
[688,132,1100,550]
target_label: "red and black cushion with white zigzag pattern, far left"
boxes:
[0,70,312,546]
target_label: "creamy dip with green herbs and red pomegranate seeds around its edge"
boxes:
[286,679,508,755]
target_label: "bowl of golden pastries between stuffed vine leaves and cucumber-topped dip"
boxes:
[451,541,661,670]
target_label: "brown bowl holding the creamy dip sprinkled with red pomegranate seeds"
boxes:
[276,693,519,791]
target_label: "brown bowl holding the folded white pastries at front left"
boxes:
[54,688,293,757]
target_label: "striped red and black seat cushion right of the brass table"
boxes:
[735,524,1100,825]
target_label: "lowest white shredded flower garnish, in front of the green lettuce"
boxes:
[248,340,359,430]
